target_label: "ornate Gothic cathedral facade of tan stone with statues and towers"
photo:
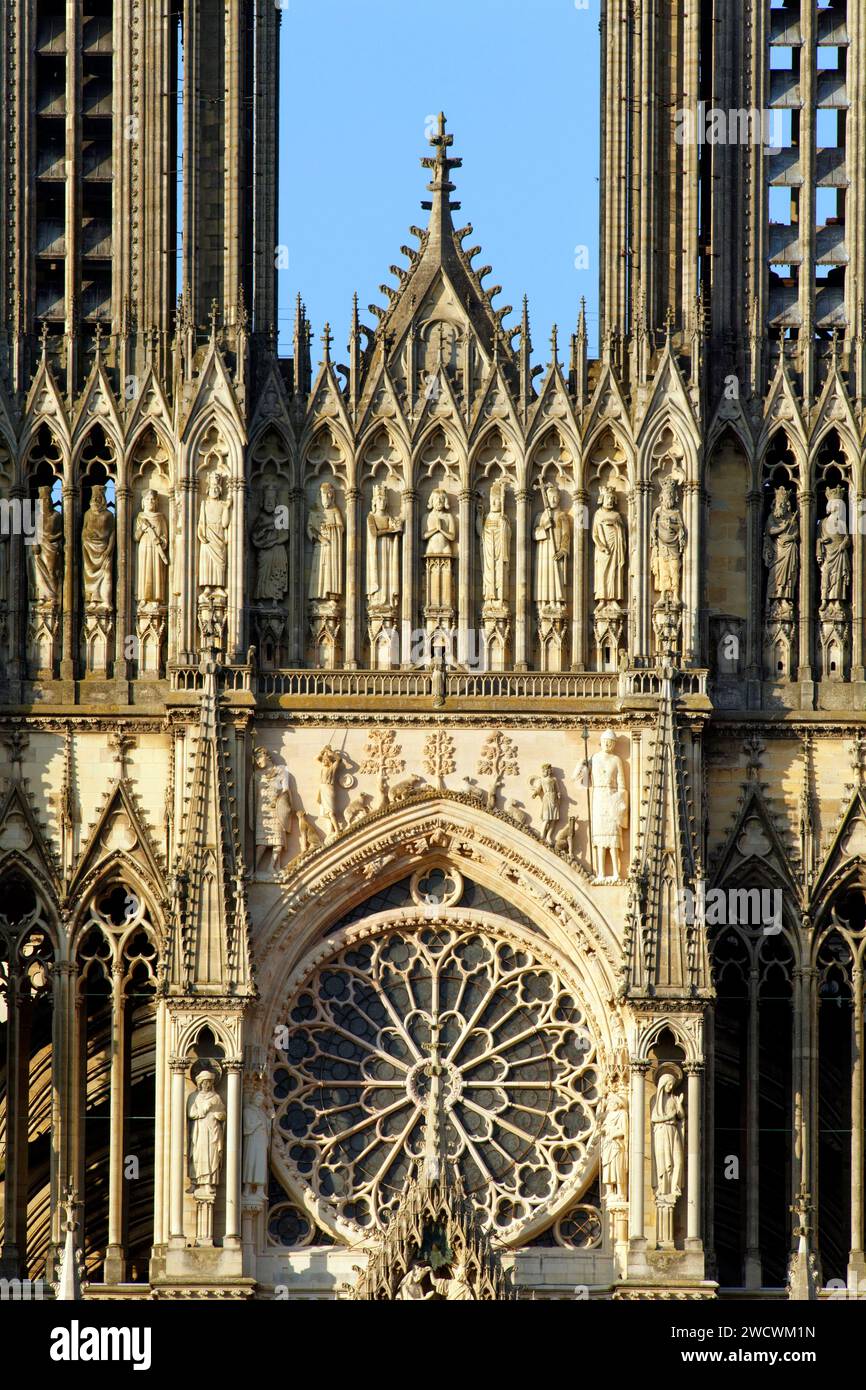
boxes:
[0,0,866,1300]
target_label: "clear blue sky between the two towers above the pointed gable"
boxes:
[278,0,599,361]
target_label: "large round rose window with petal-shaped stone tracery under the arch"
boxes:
[272,919,598,1240]
